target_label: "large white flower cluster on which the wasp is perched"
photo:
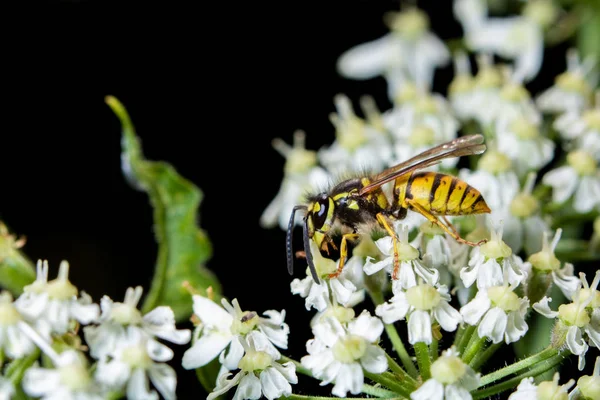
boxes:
[244,0,600,400]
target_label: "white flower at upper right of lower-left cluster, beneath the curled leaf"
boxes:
[83,286,191,358]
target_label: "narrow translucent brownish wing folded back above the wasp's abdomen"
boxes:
[359,135,486,195]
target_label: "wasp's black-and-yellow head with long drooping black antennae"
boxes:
[286,193,335,283]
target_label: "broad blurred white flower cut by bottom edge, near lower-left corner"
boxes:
[22,350,108,400]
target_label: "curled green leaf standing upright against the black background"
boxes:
[106,96,221,321]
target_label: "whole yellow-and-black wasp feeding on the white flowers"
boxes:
[286,134,491,283]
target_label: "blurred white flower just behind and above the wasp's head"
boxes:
[260,131,329,230]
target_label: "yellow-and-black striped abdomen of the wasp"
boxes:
[394,172,490,215]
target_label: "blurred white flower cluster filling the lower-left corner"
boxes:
[0,261,191,400]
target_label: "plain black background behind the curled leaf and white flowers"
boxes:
[0,0,584,398]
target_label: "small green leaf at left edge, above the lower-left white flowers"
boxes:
[0,221,35,297]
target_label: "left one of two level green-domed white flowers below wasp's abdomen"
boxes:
[375,283,462,344]
